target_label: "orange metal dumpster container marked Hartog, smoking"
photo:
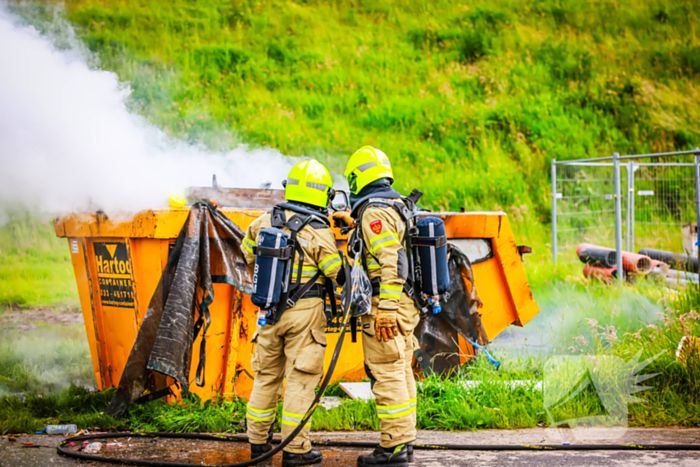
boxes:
[54,190,539,400]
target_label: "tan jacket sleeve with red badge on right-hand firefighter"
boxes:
[362,206,406,310]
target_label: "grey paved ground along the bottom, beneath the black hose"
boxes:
[0,428,700,467]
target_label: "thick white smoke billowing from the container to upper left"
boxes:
[0,5,294,217]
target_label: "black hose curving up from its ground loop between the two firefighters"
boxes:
[56,252,352,467]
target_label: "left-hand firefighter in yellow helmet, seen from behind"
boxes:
[241,160,344,466]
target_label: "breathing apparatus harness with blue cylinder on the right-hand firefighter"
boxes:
[345,189,449,316]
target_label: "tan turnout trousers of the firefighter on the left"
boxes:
[246,298,326,453]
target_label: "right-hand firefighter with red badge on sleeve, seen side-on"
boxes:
[332,146,420,466]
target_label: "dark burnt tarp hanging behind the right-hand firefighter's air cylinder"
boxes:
[415,243,488,375]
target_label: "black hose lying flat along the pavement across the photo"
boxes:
[57,432,700,467]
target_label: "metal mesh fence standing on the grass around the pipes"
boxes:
[552,148,700,279]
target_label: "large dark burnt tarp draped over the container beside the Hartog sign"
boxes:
[107,203,252,416]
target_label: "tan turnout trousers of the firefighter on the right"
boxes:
[361,293,420,448]
